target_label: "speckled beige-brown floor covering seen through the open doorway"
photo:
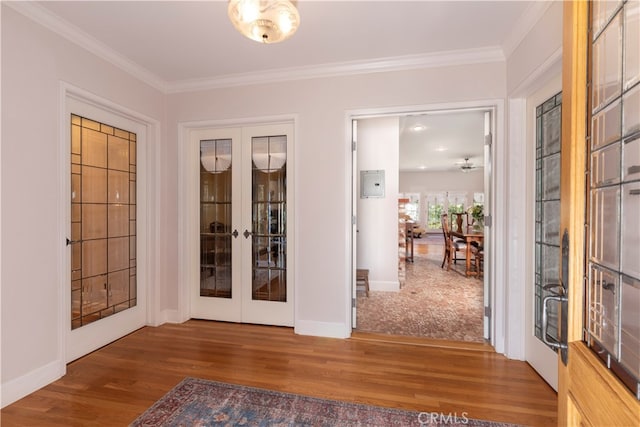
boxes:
[356,237,484,342]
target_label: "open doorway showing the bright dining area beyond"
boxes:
[352,107,495,343]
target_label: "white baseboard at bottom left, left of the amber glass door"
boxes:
[0,361,67,408]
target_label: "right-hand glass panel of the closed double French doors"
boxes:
[251,136,287,302]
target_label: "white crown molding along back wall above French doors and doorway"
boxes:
[167,47,505,93]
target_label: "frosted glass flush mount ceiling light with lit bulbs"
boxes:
[228,0,300,43]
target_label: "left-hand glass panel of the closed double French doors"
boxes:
[200,139,232,298]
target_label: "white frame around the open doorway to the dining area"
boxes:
[344,99,508,353]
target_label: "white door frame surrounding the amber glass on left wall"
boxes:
[58,82,162,364]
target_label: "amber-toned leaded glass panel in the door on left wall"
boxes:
[71,115,136,329]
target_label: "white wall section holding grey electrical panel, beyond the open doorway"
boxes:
[356,117,400,291]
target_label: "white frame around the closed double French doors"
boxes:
[177,114,298,325]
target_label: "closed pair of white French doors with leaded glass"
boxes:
[189,124,293,326]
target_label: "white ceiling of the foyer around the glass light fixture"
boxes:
[24,0,545,86]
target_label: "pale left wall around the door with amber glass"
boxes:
[1,4,165,404]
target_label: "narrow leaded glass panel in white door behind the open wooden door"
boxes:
[534,93,562,350]
